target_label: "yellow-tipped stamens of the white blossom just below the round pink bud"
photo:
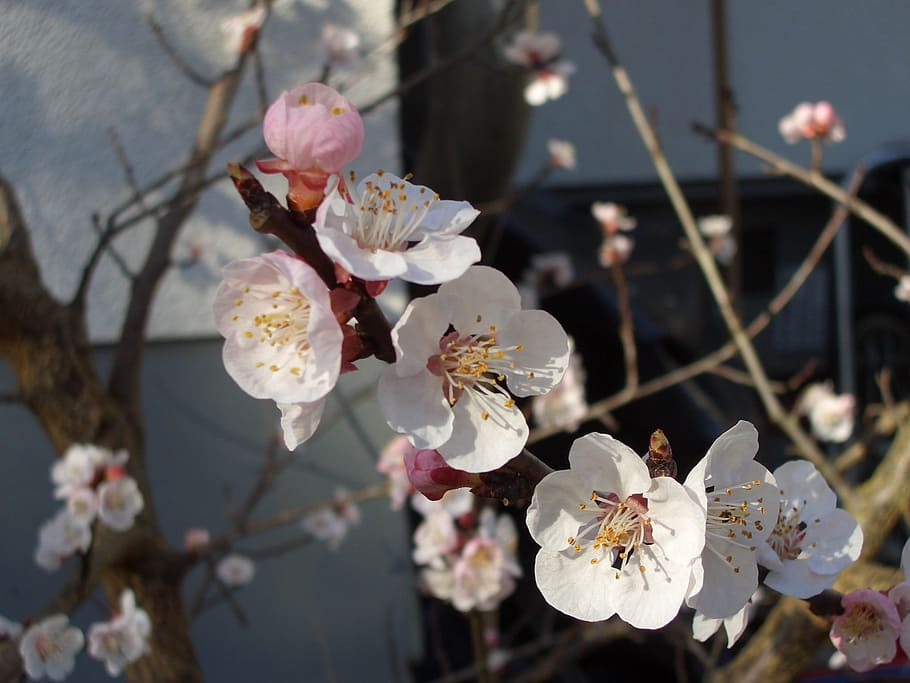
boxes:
[347,172,439,252]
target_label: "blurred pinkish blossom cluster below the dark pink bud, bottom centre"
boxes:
[412,489,521,612]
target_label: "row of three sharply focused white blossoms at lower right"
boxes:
[527,421,862,645]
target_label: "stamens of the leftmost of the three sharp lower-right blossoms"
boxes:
[566,491,654,579]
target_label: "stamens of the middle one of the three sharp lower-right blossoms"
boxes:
[705,479,765,574]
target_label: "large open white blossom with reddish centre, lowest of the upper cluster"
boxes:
[379,266,569,472]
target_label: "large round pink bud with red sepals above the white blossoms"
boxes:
[256,83,364,208]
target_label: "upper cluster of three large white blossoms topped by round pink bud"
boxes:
[214,83,568,472]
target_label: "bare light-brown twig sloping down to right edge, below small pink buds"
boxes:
[693,123,910,256]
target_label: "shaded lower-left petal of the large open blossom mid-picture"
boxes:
[379,366,455,448]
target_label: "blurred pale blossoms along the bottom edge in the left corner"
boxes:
[0,589,152,681]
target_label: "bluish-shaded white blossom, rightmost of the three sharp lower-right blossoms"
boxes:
[758,460,863,598]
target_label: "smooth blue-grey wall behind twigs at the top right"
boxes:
[522,0,910,184]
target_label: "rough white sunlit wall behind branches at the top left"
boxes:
[0,0,398,341]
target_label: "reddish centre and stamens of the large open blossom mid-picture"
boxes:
[427,325,533,420]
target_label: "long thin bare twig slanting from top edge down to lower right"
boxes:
[585,0,853,503]
